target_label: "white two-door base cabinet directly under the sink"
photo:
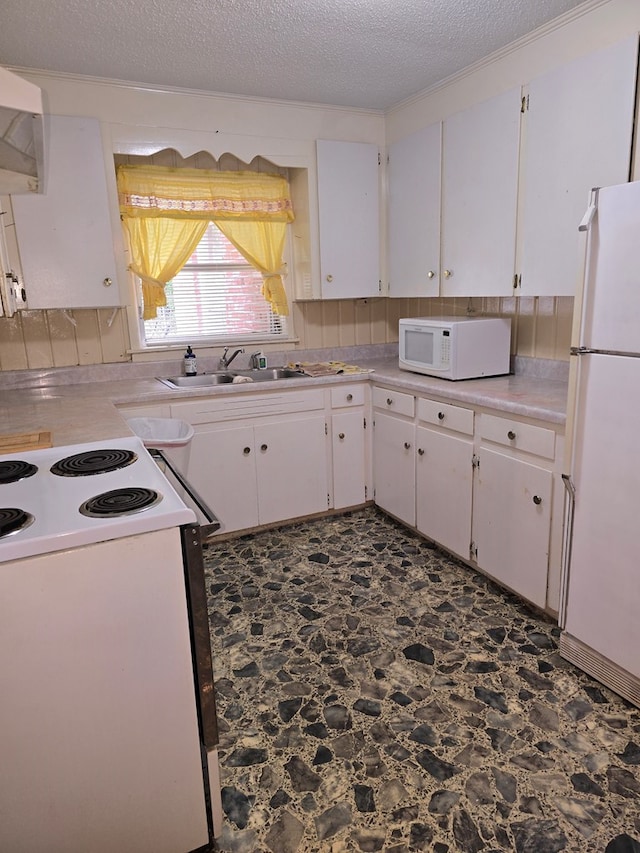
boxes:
[171,390,330,532]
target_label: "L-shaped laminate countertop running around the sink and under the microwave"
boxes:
[0,359,567,446]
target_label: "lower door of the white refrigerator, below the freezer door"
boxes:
[565,355,640,676]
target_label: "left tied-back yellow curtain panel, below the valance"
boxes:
[123,217,209,320]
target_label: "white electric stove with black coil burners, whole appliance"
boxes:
[0,437,222,853]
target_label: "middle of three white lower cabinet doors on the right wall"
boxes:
[416,427,473,560]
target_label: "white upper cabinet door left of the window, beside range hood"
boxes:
[12,116,120,308]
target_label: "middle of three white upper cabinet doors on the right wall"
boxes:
[441,88,521,296]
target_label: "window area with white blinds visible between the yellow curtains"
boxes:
[141,223,288,346]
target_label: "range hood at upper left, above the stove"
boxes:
[0,68,44,194]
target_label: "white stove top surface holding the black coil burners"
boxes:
[0,436,196,563]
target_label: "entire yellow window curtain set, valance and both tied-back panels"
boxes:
[117,166,294,319]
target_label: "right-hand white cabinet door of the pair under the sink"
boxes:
[255,416,329,524]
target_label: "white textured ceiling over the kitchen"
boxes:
[0,0,589,110]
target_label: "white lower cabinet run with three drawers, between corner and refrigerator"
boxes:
[373,388,561,611]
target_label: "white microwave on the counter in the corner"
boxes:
[399,317,511,379]
